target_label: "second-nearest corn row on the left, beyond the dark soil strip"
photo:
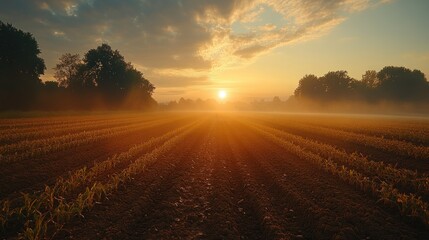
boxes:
[0,116,181,163]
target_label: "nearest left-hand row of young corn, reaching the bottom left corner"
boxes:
[0,121,201,239]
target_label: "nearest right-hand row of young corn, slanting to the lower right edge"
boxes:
[246,122,429,229]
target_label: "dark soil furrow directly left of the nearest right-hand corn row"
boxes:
[240,119,428,239]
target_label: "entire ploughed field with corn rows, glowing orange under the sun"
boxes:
[0,112,429,239]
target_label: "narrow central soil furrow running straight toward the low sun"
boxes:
[201,121,264,239]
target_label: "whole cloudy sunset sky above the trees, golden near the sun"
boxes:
[0,0,429,102]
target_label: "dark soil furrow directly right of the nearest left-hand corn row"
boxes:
[58,119,210,239]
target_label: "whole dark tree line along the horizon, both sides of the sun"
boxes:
[0,21,429,110]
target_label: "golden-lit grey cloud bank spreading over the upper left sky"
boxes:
[0,0,389,97]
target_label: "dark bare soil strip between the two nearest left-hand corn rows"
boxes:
[0,115,190,200]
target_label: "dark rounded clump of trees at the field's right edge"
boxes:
[293,66,429,104]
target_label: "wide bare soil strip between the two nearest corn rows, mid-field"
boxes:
[56,116,429,239]
